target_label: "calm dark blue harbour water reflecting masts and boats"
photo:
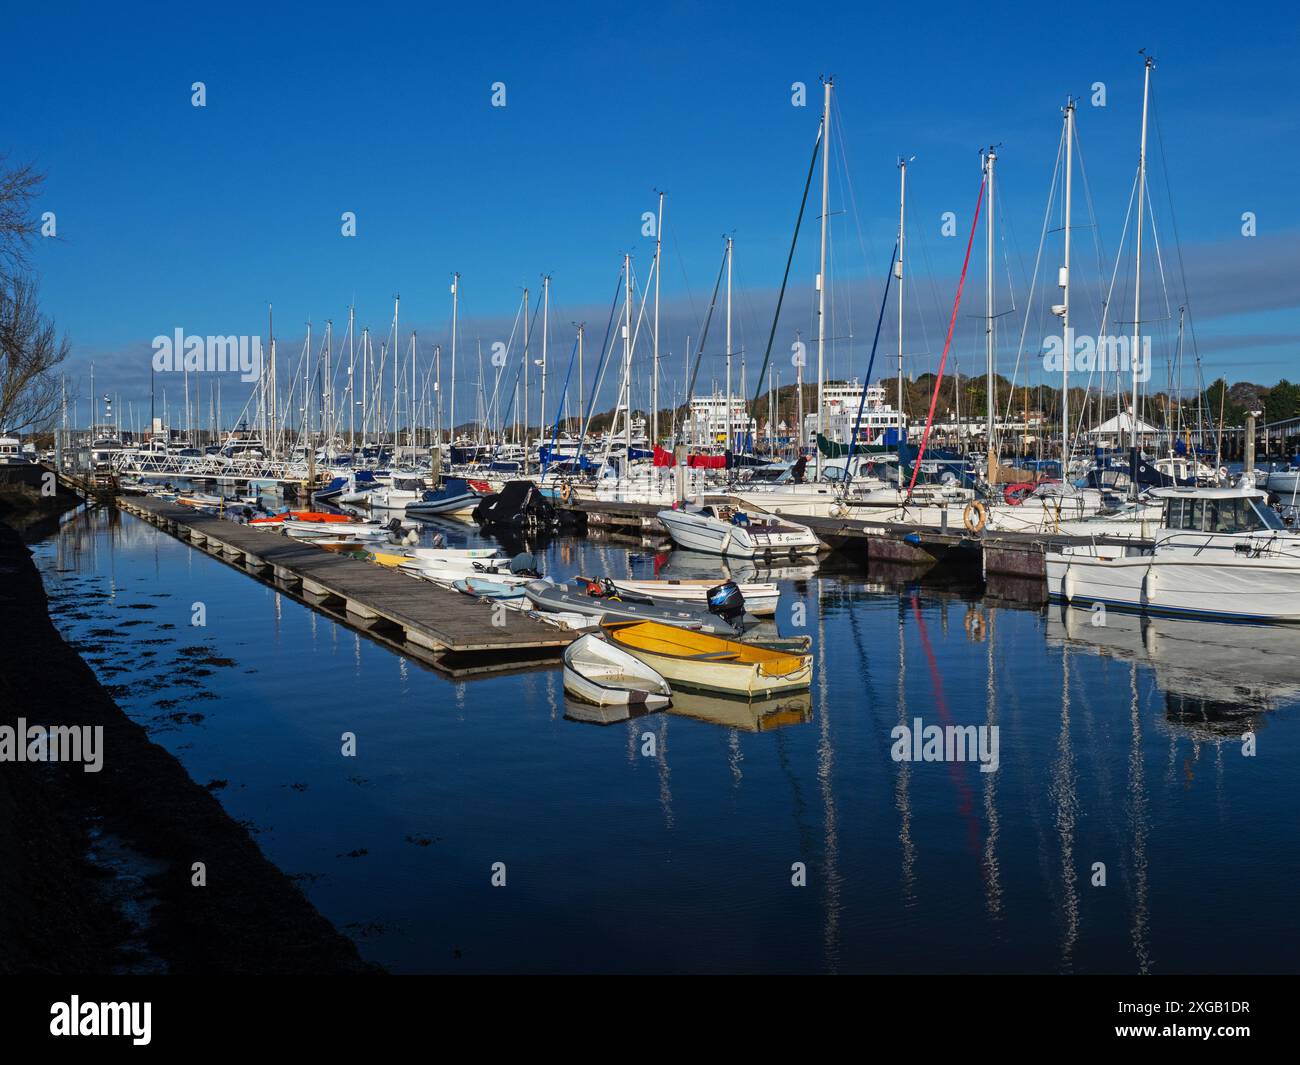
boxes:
[27,512,1300,973]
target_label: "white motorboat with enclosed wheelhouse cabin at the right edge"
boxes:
[1047,488,1300,622]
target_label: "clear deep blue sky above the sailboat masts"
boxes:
[0,3,1300,429]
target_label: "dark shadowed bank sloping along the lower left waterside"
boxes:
[0,523,374,973]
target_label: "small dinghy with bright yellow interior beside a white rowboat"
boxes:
[601,622,813,698]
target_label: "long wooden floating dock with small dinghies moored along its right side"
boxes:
[117,497,581,676]
